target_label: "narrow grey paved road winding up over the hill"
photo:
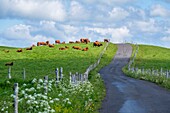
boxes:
[99,44,170,113]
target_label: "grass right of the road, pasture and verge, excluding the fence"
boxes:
[122,45,170,89]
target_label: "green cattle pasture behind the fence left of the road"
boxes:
[0,43,105,81]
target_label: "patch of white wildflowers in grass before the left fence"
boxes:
[1,78,94,113]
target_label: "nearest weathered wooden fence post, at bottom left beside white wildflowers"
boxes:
[14,83,18,113]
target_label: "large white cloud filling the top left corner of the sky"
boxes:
[0,0,66,21]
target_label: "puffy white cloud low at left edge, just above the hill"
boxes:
[1,24,54,47]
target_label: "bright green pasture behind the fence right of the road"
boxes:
[135,45,170,69]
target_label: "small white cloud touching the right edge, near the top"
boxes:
[150,4,170,17]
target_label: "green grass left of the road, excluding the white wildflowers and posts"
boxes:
[0,43,117,113]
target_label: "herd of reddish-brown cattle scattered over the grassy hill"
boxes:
[4,38,110,66]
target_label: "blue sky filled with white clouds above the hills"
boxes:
[0,0,170,48]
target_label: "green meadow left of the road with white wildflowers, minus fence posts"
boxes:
[0,43,117,113]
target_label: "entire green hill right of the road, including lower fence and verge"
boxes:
[123,45,170,89]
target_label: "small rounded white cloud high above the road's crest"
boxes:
[109,7,129,20]
